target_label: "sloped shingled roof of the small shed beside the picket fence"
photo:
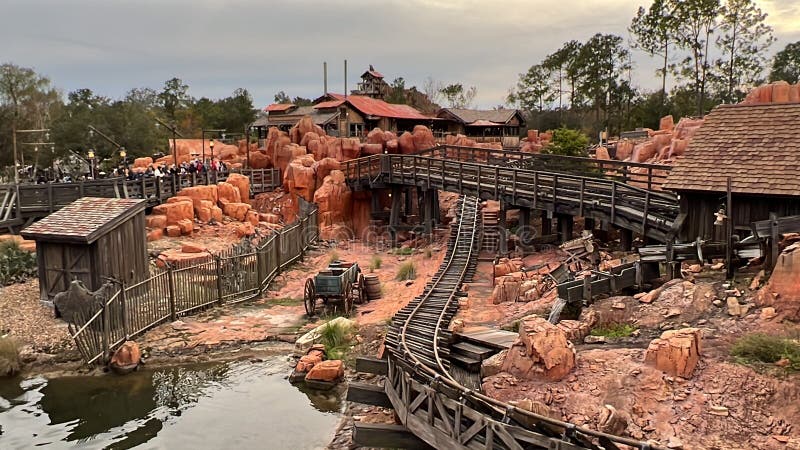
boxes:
[20,197,147,244]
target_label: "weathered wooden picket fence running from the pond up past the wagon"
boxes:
[69,208,319,364]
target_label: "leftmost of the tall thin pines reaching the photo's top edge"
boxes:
[628,0,675,110]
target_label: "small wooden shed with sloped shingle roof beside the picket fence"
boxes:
[21,197,149,302]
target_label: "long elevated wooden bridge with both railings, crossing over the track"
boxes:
[344,147,679,242]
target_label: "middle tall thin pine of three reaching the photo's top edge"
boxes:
[673,0,720,115]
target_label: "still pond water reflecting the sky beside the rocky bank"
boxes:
[0,357,342,450]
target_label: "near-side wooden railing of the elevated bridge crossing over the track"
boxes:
[344,155,678,242]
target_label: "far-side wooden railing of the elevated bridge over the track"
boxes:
[417,145,672,190]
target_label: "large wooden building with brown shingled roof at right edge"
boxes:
[664,103,800,242]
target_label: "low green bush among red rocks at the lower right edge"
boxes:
[731,333,800,370]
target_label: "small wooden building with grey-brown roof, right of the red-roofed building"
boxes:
[436,108,525,137]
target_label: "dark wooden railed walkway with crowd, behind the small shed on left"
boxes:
[0,169,281,231]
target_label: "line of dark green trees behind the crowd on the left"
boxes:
[0,63,256,171]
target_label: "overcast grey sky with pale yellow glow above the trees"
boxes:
[0,0,800,107]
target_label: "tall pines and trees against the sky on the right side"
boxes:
[506,0,800,137]
